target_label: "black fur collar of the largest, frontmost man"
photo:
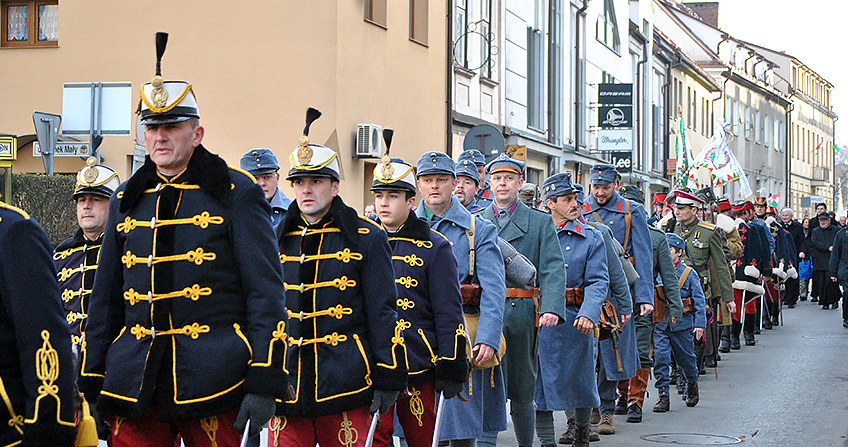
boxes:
[120,145,232,213]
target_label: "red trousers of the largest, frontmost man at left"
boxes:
[106,408,241,447]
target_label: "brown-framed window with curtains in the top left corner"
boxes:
[0,0,59,48]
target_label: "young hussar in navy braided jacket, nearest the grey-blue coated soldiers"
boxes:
[371,129,468,447]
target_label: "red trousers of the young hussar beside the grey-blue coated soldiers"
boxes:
[374,380,438,447]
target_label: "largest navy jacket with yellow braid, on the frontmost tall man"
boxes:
[79,146,288,421]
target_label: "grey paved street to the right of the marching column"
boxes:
[498,301,848,447]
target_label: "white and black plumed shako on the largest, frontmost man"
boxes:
[136,33,200,125]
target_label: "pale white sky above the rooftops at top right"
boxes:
[718,0,848,146]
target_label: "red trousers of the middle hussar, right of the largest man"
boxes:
[268,407,371,447]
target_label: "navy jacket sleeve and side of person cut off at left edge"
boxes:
[0,202,76,447]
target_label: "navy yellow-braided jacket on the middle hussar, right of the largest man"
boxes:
[277,197,408,417]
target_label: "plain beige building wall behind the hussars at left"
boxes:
[0,0,447,213]
